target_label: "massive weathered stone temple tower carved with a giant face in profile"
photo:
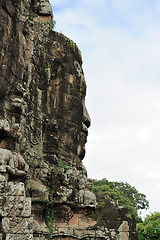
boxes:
[0,0,138,240]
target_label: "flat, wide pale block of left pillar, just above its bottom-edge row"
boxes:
[2,217,33,234]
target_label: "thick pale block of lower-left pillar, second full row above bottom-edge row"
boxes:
[1,196,31,217]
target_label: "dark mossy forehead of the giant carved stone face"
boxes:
[48,33,86,97]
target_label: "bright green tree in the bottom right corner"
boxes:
[136,212,160,240]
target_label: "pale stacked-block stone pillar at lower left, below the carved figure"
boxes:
[0,163,33,240]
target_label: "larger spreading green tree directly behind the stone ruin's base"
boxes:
[93,178,149,216]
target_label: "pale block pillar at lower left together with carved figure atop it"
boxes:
[0,148,33,240]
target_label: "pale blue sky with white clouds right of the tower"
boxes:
[50,0,160,217]
